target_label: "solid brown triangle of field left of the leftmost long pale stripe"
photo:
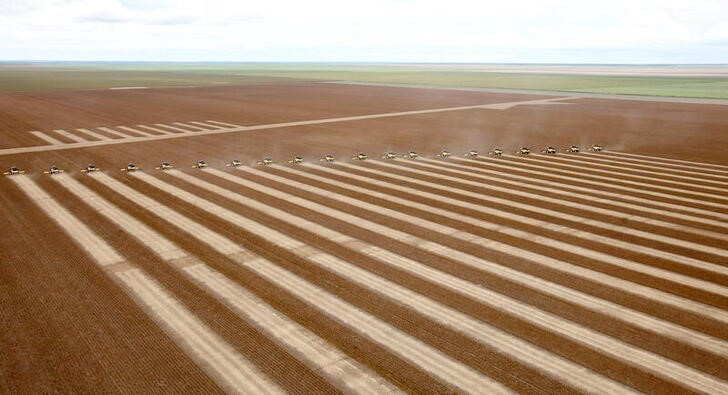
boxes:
[0,180,220,393]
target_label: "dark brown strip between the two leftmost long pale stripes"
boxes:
[44,175,334,392]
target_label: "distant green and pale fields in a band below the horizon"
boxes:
[0,63,728,99]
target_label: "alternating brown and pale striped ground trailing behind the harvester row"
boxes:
[2,150,728,393]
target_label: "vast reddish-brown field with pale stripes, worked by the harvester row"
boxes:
[0,83,728,394]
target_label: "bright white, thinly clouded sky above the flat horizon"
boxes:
[0,0,728,64]
